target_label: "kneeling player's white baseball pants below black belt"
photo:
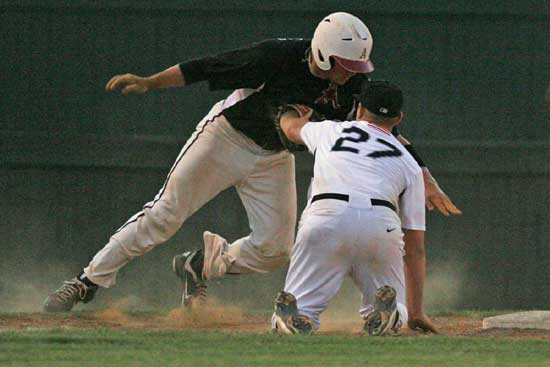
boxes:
[284,197,408,328]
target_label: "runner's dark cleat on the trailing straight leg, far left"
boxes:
[44,278,98,312]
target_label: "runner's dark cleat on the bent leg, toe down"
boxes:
[172,250,207,307]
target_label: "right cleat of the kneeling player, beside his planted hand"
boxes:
[364,285,401,336]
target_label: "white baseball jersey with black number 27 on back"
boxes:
[301,121,425,230]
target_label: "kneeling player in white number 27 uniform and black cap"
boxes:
[272,81,436,335]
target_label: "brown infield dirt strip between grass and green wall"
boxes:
[0,306,550,340]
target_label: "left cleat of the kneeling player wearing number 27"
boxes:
[271,291,313,335]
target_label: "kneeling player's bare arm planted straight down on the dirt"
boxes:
[403,229,439,334]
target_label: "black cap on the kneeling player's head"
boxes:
[359,80,403,117]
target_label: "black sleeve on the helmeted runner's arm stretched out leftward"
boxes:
[179,40,286,90]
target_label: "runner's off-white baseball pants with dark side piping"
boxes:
[84,98,296,288]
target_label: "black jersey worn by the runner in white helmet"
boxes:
[179,39,365,150]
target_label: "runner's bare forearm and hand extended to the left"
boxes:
[105,65,185,94]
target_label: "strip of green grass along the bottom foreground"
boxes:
[0,328,550,367]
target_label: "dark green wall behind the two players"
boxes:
[0,0,550,311]
